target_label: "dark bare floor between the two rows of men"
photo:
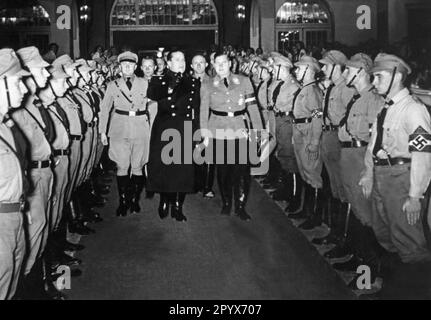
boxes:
[65,178,357,300]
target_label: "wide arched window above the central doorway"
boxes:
[111,0,218,30]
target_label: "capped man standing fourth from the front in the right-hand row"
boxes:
[289,56,322,223]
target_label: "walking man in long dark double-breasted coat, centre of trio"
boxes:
[147,50,198,221]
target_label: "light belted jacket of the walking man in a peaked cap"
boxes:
[99,76,156,139]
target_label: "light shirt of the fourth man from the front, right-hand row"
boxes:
[293,82,322,145]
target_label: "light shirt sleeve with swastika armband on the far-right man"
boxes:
[405,104,431,198]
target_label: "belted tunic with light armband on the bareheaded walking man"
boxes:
[200,74,263,139]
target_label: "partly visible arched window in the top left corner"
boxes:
[0,5,51,27]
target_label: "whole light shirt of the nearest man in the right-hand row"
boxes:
[365,88,431,198]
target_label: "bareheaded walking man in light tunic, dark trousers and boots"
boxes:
[200,52,263,220]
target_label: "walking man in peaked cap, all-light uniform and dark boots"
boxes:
[99,52,156,216]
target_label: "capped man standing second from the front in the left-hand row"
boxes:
[12,47,55,275]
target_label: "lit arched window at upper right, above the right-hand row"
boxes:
[276,0,332,51]
